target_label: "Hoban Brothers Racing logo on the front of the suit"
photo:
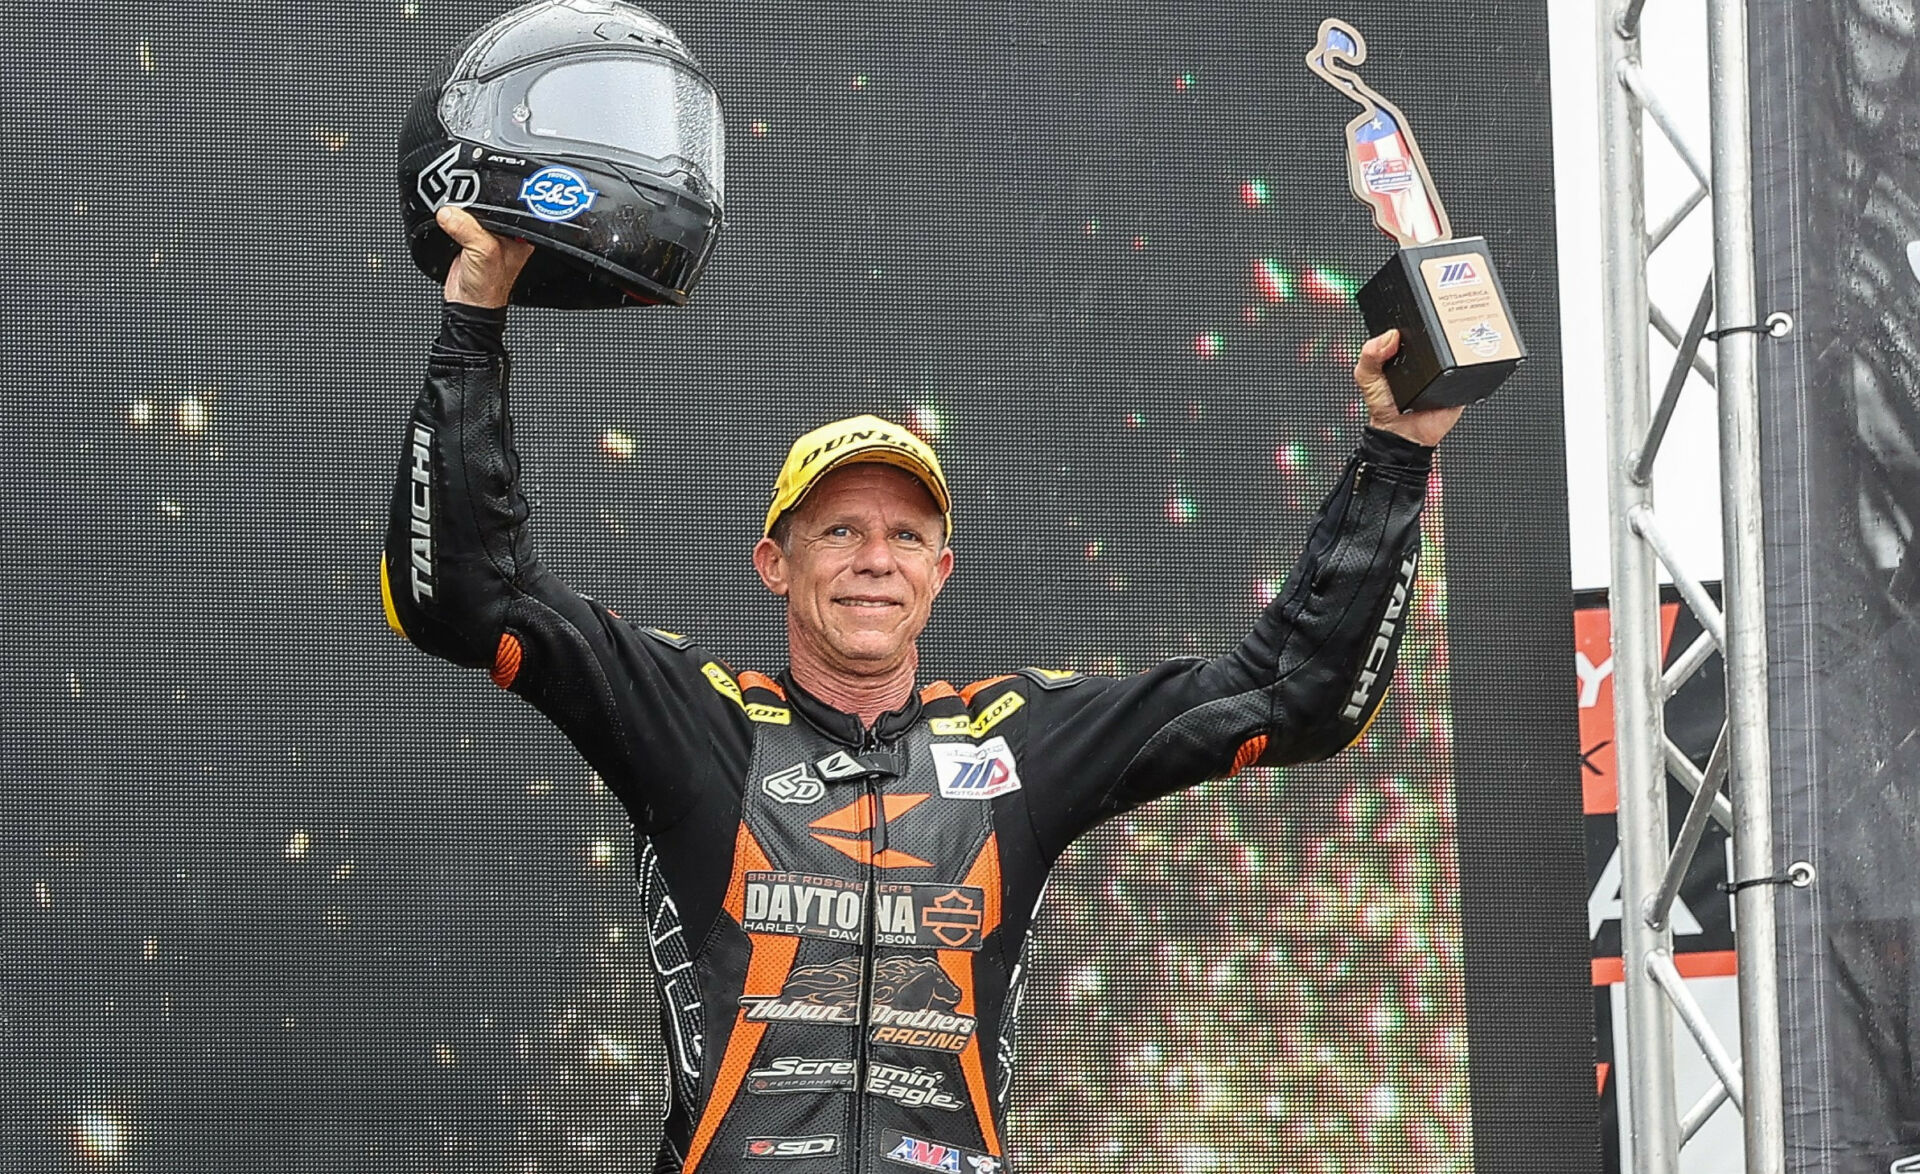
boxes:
[739,955,977,1055]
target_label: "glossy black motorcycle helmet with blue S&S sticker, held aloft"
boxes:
[397,0,726,309]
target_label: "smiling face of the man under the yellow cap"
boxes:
[753,461,954,676]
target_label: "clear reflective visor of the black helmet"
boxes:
[511,54,726,196]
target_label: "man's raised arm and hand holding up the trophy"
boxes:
[1023,334,1459,853]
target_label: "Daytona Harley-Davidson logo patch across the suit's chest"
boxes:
[741,872,987,949]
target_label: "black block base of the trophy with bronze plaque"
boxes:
[1354,236,1526,411]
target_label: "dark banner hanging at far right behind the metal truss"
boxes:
[1758,0,1920,1174]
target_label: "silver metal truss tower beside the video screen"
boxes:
[1597,0,1803,1174]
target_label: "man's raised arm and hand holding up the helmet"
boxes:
[380,211,745,826]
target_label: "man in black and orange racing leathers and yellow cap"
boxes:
[380,209,1459,1174]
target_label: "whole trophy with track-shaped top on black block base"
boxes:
[1308,19,1526,411]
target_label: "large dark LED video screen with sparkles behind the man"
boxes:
[0,0,1592,1174]
